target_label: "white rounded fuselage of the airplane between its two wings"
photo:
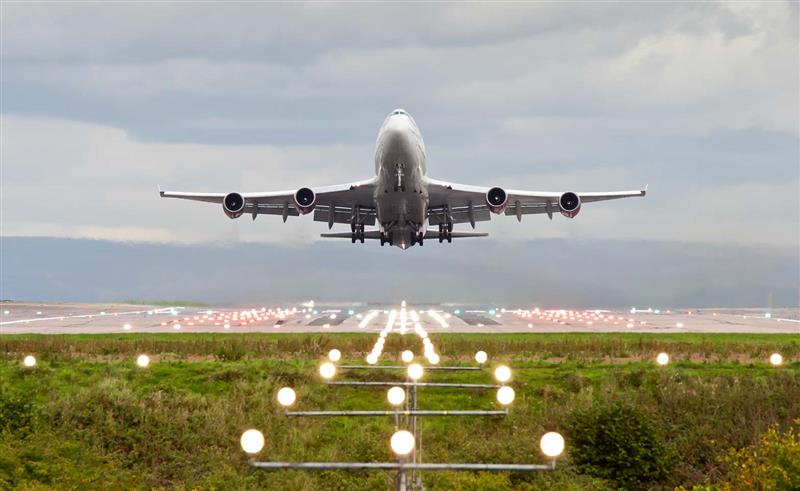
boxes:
[375,109,428,249]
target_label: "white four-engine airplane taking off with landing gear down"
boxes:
[159,109,647,250]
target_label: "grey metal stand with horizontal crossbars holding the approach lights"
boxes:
[250,365,556,491]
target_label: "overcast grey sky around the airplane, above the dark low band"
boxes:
[0,2,800,306]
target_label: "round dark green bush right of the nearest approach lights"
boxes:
[567,403,670,489]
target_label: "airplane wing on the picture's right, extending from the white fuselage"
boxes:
[428,179,647,227]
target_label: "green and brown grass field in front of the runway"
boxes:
[0,333,800,490]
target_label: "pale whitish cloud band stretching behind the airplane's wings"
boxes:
[2,115,798,248]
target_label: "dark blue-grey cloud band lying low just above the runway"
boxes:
[0,237,800,308]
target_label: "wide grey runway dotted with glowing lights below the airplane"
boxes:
[0,302,800,335]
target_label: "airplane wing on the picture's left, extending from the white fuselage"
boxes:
[159,178,376,226]
